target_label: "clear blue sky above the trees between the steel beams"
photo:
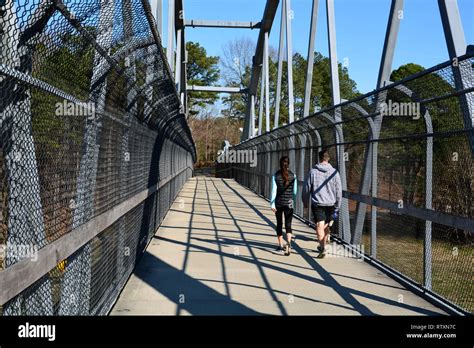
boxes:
[164,0,474,93]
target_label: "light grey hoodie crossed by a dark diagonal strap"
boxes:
[302,163,342,209]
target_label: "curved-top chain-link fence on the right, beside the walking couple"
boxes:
[217,55,474,313]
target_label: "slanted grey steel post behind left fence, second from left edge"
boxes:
[59,0,116,315]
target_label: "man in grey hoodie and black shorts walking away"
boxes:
[302,150,342,258]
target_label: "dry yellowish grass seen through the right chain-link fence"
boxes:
[362,213,474,313]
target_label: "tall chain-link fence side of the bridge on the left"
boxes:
[0,0,195,315]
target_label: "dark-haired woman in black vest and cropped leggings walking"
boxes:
[270,156,297,256]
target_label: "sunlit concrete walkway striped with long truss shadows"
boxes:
[111,177,444,315]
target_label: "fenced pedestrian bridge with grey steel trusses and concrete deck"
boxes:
[0,0,474,316]
